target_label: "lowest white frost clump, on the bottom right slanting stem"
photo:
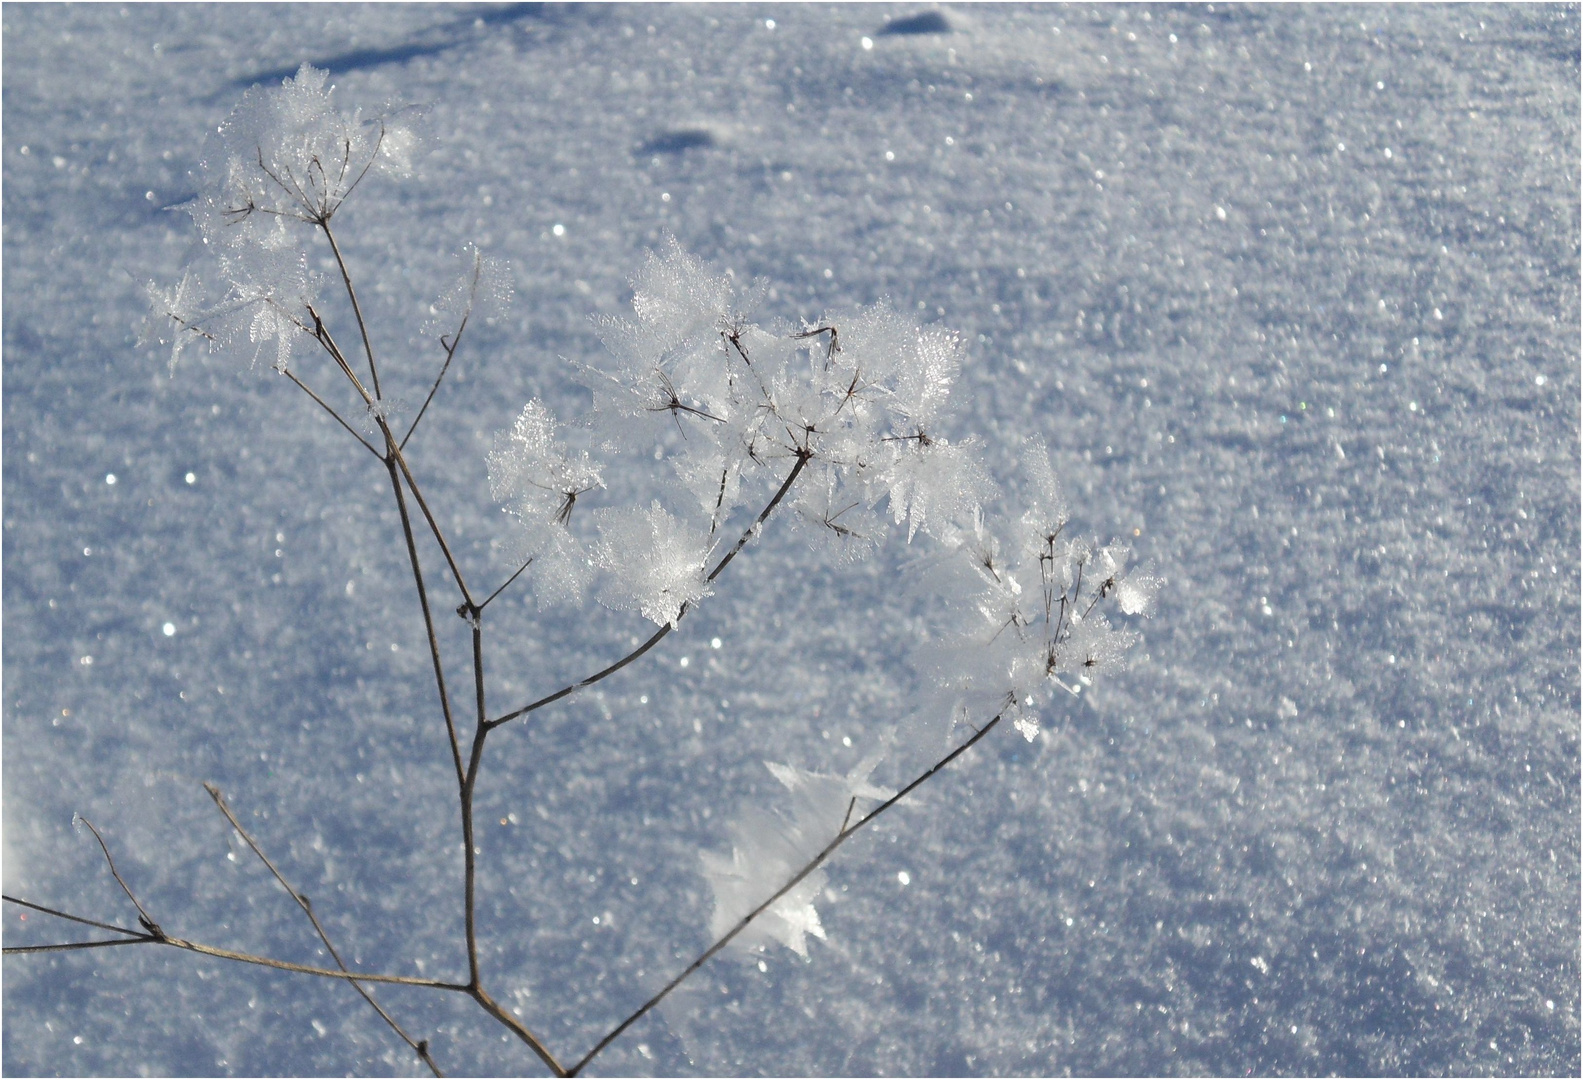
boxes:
[701,755,894,958]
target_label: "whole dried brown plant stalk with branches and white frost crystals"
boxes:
[5,67,1160,1075]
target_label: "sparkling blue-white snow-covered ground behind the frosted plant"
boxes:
[0,5,1580,1075]
